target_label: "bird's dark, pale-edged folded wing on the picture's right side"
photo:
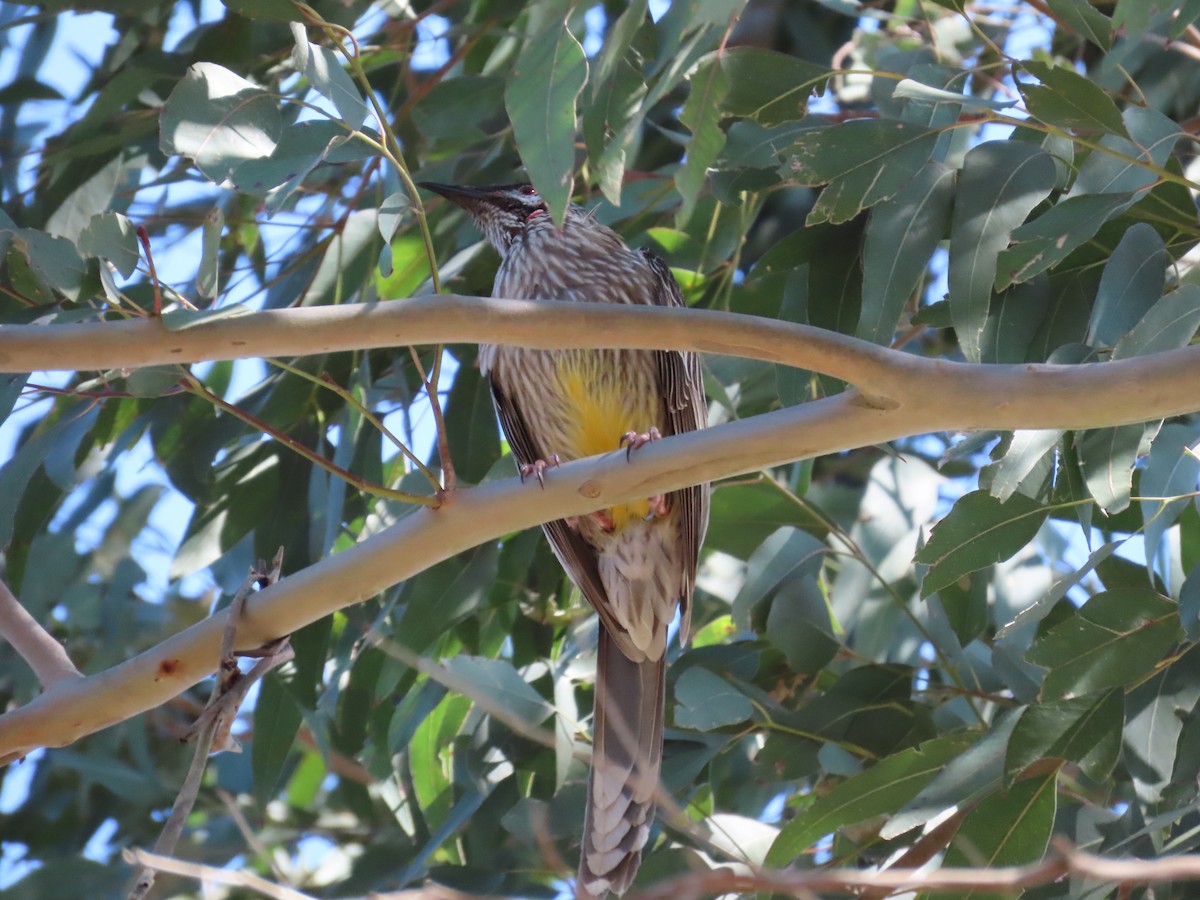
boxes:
[638,250,709,640]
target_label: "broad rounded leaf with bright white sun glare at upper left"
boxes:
[160,62,282,184]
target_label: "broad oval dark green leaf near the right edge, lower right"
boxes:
[1026,588,1180,698]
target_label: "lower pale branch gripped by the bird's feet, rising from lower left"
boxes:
[0,354,1200,760]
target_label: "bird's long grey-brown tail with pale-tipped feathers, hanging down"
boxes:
[577,626,666,898]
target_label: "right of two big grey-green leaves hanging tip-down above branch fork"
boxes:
[948,140,1056,361]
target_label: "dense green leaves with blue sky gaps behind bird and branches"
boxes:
[0,0,1200,898]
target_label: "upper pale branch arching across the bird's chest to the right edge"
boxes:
[0,294,1200,428]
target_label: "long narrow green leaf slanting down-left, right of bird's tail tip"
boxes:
[766,734,974,868]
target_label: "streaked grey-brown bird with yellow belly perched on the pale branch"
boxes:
[421,182,709,898]
